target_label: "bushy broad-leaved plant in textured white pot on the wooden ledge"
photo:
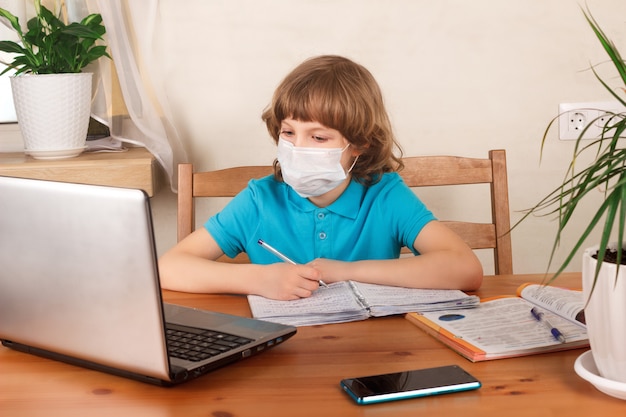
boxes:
[0,0,110,159]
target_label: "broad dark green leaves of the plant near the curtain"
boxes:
[0,0,110,75]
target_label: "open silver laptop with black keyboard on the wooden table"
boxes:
[0,177,296,385]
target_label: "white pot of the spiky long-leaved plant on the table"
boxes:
[582,246,626,382]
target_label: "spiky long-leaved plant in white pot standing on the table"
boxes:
[518,10,626,394]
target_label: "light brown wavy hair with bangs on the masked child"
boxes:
[262,55,403,184]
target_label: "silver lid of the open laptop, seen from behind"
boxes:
[0,177,168,378]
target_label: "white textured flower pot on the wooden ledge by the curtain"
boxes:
[11,73,92,159]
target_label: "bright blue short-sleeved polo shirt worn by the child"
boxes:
[205,173,435,264]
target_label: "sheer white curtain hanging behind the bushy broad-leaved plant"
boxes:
[0,0,187,190]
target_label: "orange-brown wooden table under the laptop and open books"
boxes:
[0,274,626,417]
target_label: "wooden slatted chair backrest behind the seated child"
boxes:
[178,150,513,274]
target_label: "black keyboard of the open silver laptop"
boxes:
[166,323,252,362]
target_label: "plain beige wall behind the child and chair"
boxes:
[4,0,626,273]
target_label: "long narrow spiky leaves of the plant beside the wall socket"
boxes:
[517,6,626,292]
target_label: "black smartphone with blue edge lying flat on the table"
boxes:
[341,365,481,404]
